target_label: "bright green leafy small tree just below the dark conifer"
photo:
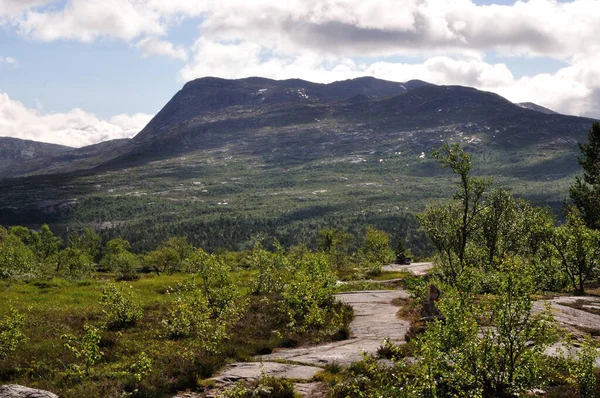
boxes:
[551,207,600,294]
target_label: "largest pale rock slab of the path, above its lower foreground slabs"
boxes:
[260,290,410,366]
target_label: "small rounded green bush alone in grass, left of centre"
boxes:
[100,284,144,330]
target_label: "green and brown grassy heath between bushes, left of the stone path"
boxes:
[0,270,352,398]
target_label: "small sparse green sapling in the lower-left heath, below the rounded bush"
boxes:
[61,324,104,376]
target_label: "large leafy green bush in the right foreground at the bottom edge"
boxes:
[417,259,555,397]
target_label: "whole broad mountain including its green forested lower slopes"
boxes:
[0,78,592,251]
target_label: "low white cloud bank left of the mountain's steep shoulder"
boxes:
[0,93,152,147]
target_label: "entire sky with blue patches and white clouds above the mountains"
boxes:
[0,0,600,147]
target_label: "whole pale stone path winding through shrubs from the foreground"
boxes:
[204,290,410,397]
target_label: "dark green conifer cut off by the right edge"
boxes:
[569,122,600,230]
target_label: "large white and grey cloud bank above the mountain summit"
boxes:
[0,0,600,121]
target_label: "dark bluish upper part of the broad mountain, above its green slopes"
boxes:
[112,78,591,165]
